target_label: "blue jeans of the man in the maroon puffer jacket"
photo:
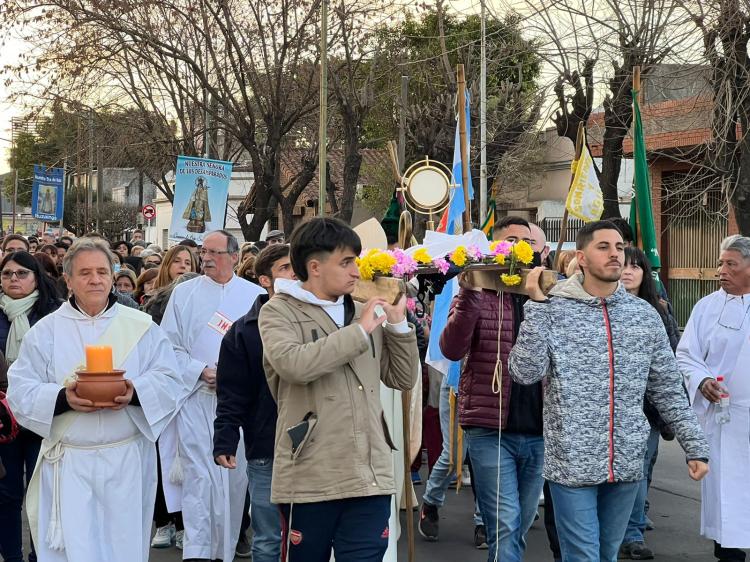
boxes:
[466,427,544,562]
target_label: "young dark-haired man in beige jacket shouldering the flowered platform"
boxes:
[259,218,419,562]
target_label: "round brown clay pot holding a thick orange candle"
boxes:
[76,345,128,408]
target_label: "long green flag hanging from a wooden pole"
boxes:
[630,90,661,269]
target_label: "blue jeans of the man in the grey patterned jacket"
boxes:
[549,476,640,562]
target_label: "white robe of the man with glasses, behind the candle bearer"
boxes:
[159,276,265,560]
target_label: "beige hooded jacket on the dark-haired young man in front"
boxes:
[259,294,419,503]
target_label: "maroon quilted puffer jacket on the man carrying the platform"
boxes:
[440,289,521,429]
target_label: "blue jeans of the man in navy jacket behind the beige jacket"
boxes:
[247,459,281,562]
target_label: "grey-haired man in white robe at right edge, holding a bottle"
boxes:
[677,231,750,562]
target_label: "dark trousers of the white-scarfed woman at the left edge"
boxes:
[0,429,42,562]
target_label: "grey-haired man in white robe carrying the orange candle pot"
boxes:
[8,239,180,562]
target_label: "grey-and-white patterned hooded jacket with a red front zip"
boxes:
[508,274,709,486]
